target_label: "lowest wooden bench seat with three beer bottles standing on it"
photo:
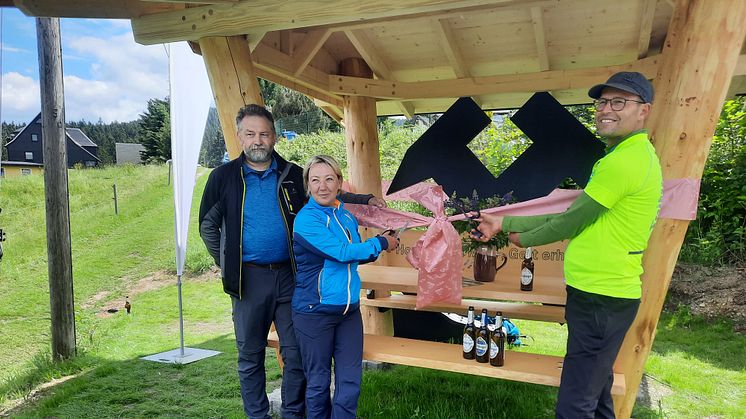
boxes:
[268,332,625,395]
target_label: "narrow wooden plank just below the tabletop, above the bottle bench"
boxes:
[360,294,565,323]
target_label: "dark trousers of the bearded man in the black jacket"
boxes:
[232,264,306,419]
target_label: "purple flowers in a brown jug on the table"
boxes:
[445,190,514,282]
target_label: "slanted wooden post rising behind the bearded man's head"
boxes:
[199,36,264,159]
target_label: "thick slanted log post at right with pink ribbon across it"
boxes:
[614,0,746,418]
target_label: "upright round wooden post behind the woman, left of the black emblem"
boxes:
[339,57,394,336]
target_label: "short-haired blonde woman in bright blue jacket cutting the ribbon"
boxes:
[293,156,399,418]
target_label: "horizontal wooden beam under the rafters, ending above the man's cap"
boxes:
[329,56,659,100]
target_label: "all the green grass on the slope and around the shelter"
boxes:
[0,166,746,418]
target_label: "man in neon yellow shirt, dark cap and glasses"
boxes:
[475,72,663,419]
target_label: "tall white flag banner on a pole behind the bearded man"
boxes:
[169,42,212,276]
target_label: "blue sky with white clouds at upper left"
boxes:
[0,8,168,123]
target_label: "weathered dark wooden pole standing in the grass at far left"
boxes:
[36,18,75,360]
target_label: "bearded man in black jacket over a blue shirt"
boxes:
[199,105,386,418]
